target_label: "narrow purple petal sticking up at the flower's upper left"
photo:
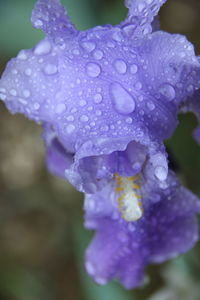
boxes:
[31,0,76,39]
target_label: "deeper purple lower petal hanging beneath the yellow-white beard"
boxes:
[85,172,200,288]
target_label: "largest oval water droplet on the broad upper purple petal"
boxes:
[110,82,135,114]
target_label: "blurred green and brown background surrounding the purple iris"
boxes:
[0,0,200,300]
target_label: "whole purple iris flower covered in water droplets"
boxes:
[0,0,200,288]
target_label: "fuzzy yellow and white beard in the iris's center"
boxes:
[115,174,143,222]
